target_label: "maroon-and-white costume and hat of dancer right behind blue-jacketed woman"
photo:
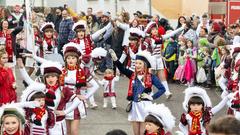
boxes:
[119,28,145,71]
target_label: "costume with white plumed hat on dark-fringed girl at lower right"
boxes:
[179,87,228,135]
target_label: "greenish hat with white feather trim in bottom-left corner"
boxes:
[0,104,25,125]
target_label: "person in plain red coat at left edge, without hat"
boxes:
[0,47,17,106]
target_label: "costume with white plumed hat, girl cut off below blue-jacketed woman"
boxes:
[144,104,175,135]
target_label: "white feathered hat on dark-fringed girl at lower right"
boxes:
[182,87,212,112]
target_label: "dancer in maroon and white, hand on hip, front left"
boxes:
[18,58,86,135]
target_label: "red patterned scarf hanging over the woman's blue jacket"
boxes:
[128,71,152,97]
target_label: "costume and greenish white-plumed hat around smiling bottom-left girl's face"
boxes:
[0,104,25,135]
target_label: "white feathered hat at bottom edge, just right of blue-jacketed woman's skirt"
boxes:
[145,104,175,131]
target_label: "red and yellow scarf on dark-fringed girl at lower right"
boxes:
[189,112,202,135]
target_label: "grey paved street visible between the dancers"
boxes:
[17,69,226,135]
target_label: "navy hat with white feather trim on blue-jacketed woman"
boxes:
[136,51,155,68]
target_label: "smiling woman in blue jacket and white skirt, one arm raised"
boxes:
[109,49,165,135]
